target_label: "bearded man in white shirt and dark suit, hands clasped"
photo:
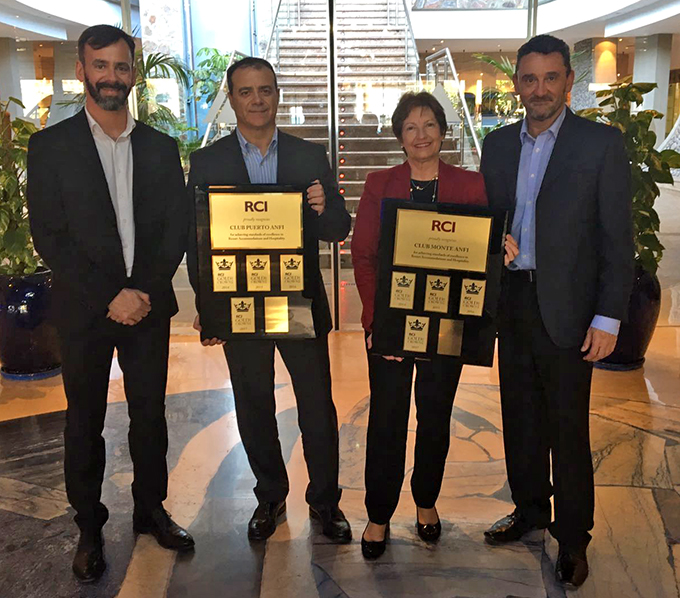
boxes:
[28,25,194,582]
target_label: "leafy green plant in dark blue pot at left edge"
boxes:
[0,98,60,379]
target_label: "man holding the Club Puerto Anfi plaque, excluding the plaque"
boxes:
[187,58,352,542]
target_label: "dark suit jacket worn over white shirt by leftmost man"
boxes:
[28,110,188,336]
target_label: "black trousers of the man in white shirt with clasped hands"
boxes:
[59,315,170,529]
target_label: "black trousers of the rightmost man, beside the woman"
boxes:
[498,273,595,547]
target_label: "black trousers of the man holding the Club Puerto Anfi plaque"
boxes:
[224,335,340,507]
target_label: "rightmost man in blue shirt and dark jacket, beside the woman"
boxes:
[481,35,633,586]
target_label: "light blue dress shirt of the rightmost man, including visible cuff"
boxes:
[508,108,621,334]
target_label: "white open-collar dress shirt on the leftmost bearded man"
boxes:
[85,108,136,277]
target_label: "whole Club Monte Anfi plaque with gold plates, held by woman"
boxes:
[372,199,507,366]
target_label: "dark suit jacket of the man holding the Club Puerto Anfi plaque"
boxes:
[187,131,352,335]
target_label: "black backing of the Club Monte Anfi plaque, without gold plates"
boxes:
[372,199,507,366]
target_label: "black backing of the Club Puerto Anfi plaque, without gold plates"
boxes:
[194,185,316,340]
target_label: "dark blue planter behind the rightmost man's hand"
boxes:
[595,267,661,372]
